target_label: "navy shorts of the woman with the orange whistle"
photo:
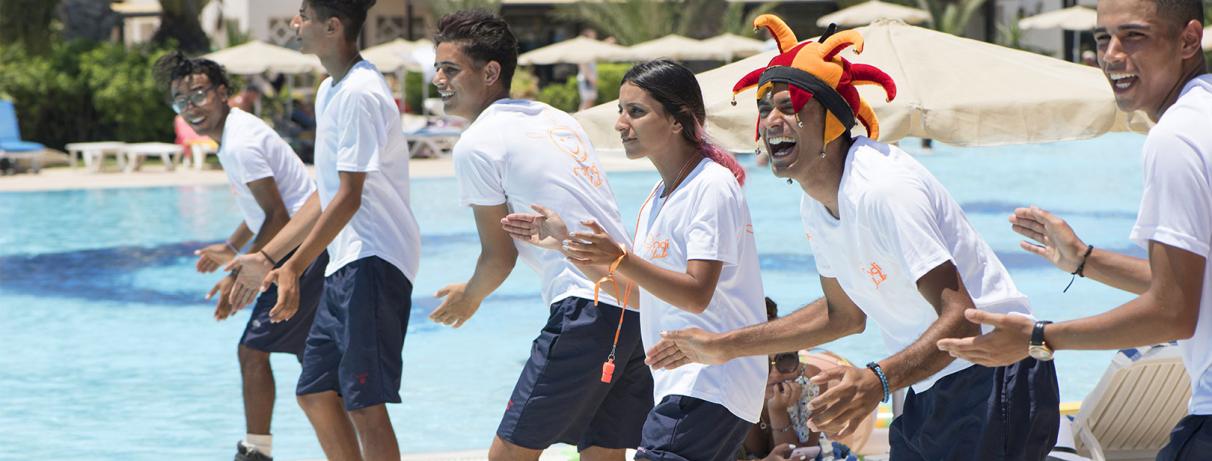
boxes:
[635,395,753,461]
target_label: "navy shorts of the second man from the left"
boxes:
[295,256,412,411]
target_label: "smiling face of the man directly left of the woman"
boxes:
[433,41,499,120]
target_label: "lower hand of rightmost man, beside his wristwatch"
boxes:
[937,309,1035,366]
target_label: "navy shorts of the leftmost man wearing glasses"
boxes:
[240,251,328,360]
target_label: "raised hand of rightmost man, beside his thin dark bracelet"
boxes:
[1010,206,1086,273]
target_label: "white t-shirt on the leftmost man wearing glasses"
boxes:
[219,109,315,233]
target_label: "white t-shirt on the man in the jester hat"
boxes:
[800,137,1031,393]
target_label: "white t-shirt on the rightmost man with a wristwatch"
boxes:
[1131,75,1212,415]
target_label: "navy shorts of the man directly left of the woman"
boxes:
[497,297,652,450]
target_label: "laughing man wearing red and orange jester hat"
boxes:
[647,15,1059,461]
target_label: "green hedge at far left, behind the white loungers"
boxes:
[0,41,175,149]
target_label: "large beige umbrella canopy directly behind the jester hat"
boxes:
[576,21,1128,150]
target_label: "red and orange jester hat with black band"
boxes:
[732,15,897,146]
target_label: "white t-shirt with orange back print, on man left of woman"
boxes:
[452,99,631,306]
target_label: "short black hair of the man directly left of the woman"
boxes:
[434,10,518,90]
